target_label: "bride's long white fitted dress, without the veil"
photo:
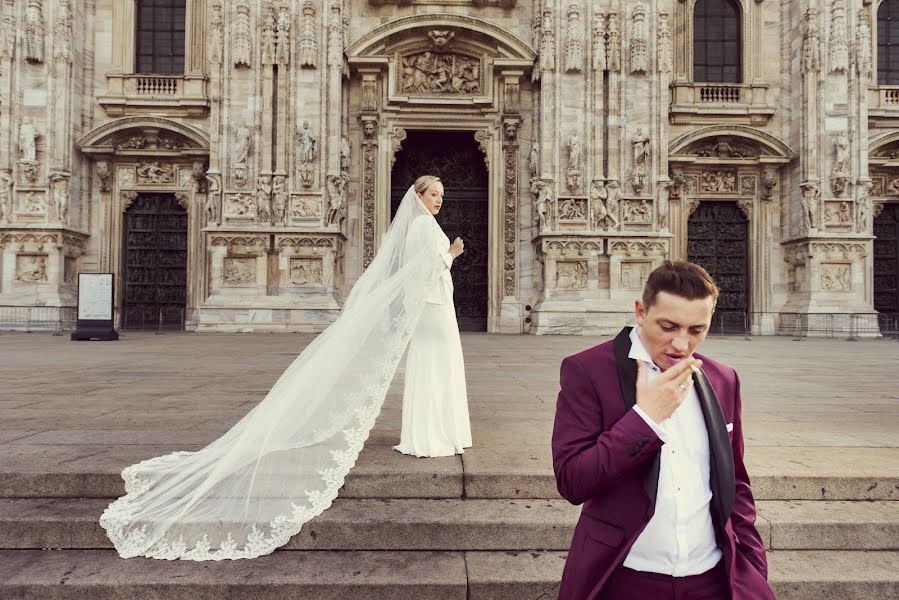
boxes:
[394,214,471,457]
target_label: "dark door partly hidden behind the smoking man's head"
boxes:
[687,201,750,334]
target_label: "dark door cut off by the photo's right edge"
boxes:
[874,204,899,332]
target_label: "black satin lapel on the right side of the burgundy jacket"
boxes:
[693,369,736,528]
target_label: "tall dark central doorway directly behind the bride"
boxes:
[390,130,489,331]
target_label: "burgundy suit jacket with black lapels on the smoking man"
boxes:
[552,327,774,600]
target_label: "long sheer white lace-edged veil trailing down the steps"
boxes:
[100,188,446,561]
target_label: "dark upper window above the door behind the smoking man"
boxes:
[693,0,743,83]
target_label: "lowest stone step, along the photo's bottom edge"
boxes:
[0,550,899,600]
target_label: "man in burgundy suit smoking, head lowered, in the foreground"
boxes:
[552,261,774,600]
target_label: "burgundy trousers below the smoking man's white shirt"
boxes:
[599,561,730,600]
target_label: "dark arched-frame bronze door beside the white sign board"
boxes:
[122,194,187,329]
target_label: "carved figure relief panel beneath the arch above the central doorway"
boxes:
[401,50,481,94]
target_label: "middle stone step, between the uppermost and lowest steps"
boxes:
[0,498,899,551]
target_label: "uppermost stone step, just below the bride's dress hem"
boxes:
[0,443,899,501]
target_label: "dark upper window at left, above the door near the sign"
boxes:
[135,0,186,75]
